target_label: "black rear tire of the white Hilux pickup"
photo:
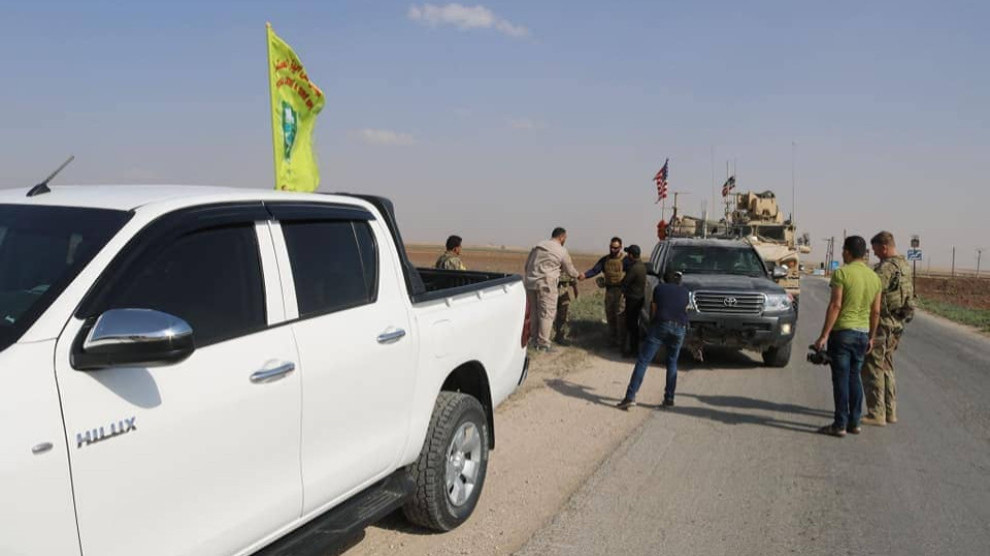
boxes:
[402,392,489,531]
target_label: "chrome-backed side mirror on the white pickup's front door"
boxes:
[72,309,196,371]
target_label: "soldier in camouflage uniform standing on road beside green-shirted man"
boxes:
[862,232,916,426]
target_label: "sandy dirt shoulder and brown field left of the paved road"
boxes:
[327,246,648,556]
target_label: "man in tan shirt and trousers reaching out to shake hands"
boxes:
[523,228,584,352]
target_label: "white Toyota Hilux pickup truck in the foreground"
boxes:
[0,185,529,556]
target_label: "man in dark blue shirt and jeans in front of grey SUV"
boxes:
[617,270,689,409]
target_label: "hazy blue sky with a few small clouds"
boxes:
[0,0,990,268]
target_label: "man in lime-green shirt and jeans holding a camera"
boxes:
[813,236,881,438]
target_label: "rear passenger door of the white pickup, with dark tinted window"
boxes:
[269,205,416,513]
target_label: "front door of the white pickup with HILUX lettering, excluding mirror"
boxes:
[55,207,302,556]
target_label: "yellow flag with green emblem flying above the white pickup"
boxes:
[267,24,326,191]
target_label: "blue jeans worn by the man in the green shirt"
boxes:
[828,330,870,430]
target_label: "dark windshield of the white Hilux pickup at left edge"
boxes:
[0,205,130,351]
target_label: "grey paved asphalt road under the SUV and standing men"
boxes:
[520,279,990,555]
